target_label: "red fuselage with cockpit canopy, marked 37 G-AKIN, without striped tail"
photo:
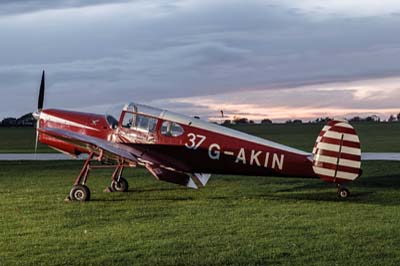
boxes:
[39,106,317,178]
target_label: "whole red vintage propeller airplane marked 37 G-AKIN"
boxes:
[33,72,398,201]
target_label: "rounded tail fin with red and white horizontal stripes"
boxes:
[313,120,361,183]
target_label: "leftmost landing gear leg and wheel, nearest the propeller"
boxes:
[67,152,94,201]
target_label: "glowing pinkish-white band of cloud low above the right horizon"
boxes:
[151,78,400,121]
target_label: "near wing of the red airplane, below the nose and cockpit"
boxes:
[38,128,140,163]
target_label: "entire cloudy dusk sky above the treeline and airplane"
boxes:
[0,0,400,121]
